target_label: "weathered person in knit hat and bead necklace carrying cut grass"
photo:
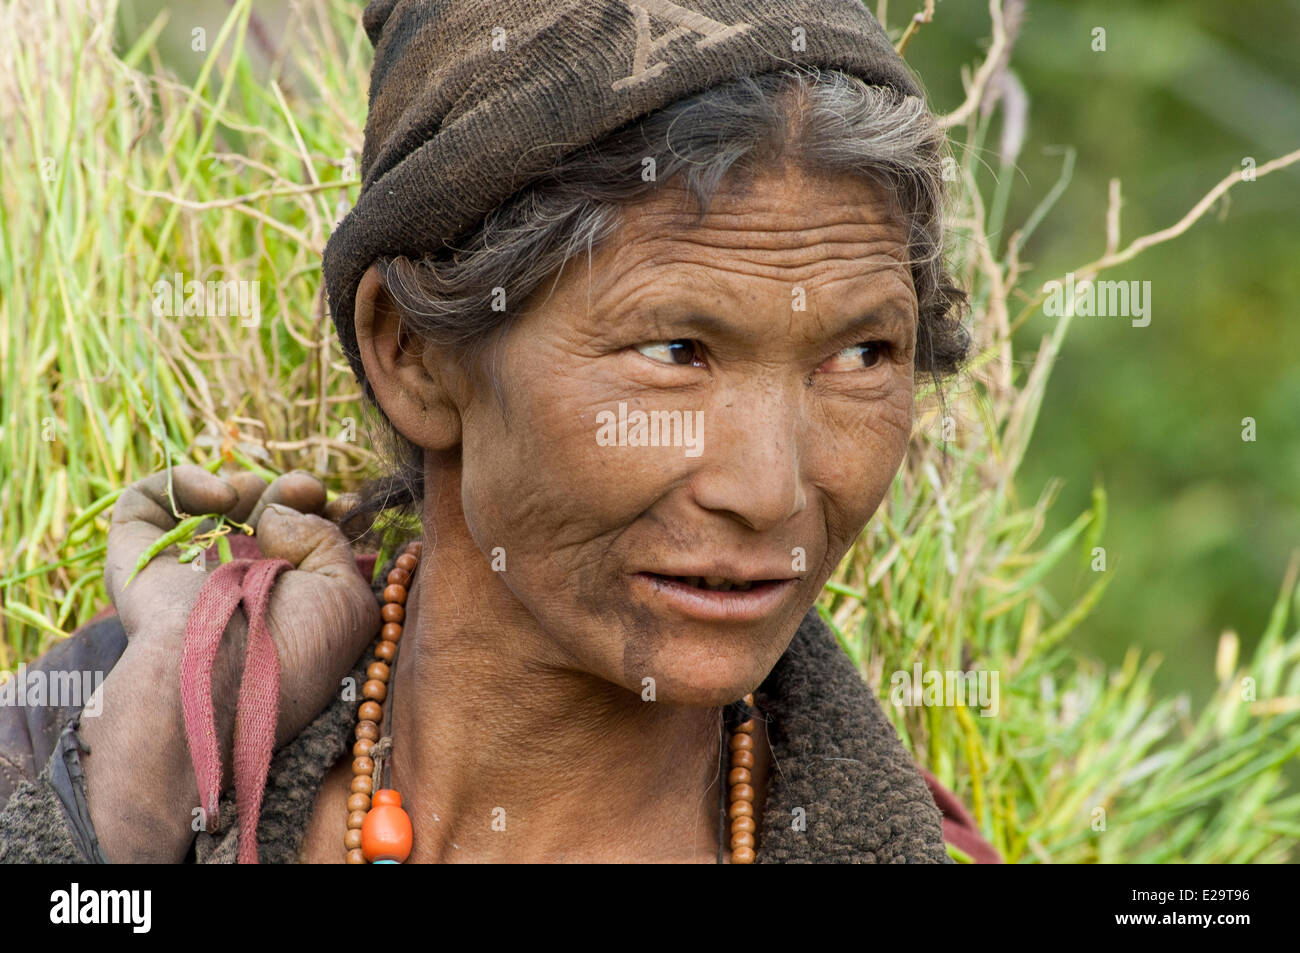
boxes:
[0,0,983,863]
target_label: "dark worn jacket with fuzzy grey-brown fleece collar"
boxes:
[0,556,998,863]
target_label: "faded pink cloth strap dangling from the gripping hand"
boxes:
[181,559,294,863]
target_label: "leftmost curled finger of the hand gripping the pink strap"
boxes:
[104,464,239,603]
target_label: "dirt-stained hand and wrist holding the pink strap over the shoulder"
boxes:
[82,465,380,863]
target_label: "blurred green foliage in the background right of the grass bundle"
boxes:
[889,0,1300,703]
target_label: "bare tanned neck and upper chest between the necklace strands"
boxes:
[390,523,723,863]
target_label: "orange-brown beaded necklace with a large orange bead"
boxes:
[343,542,757,863]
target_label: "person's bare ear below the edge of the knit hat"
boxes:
[352,264,464,451]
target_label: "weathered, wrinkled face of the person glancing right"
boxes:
[462,159,917,705]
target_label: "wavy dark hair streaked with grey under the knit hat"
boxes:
[345,66,970,529]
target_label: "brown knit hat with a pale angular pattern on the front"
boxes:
[324,0,922,384]
